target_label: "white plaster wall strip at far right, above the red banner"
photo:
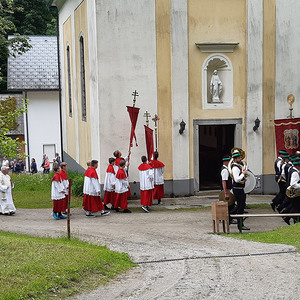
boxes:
[275,0,300,119]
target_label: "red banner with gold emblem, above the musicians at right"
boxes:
[274,118,300,154]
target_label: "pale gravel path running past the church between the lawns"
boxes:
[0,198,300,300]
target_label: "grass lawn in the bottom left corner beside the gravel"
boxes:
[0,232,134,300]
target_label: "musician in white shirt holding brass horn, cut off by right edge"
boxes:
[283,158,300,225]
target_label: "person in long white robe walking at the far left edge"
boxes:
[0,166,16,216]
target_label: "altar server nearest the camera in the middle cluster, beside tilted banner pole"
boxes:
[115,160,131,213]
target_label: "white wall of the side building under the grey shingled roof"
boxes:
[25,91,61,170]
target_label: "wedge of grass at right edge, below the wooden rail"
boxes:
[224,223,300,250]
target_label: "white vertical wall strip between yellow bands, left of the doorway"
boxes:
[171,0,189,180]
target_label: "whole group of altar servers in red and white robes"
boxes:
[51,150,164,219]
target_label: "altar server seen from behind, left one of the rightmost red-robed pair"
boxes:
[138,156,154,213]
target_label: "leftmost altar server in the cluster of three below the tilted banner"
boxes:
[103,157,116,209]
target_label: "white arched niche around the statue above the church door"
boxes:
[202,53,233,109]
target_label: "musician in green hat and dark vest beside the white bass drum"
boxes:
[231,151,250,230]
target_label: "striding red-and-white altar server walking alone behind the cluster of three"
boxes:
[83,160,109,217]
